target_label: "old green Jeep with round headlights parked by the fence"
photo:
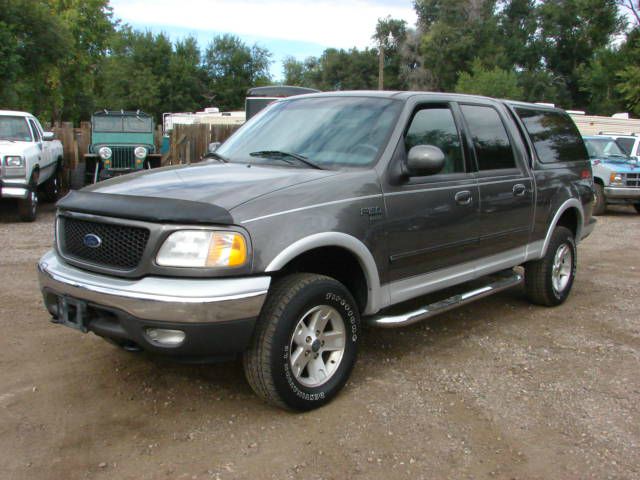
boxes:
[72,110,162,189]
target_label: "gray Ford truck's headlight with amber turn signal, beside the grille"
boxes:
[156,230,247,268]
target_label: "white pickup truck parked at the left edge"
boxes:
[0,110,62,222]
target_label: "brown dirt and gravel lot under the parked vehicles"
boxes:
[0,204,640,480]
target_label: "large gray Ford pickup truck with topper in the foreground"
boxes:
[38,92,595,410]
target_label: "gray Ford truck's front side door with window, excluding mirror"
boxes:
[384,103,480,284]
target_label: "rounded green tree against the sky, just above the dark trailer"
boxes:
[204,34,271,110]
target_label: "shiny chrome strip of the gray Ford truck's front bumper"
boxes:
[38,250,271,324]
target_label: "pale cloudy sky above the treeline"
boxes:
[111,0,417,80]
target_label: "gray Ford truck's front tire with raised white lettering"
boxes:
[244,274,360,411]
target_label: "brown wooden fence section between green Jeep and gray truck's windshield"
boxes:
[163,124,240,165]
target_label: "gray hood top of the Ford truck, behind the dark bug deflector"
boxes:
[83,161,340,210]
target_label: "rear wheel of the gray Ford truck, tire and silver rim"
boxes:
[524,227,577,307]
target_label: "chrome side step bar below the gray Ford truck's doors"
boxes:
[368,272,524,328]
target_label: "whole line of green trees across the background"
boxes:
[0,0,640,122]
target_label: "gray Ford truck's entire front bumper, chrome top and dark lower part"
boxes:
[38,251,271,356]
